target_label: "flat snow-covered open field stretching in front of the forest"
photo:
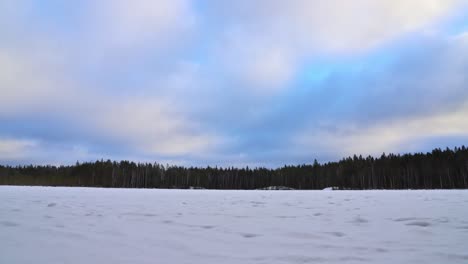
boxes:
[0,187,468,264]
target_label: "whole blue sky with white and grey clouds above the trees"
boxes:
[0,0,468,167]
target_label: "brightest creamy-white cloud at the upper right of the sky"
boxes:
[302,0,461,53]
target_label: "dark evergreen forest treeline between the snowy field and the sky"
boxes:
[0,146,468,189]
